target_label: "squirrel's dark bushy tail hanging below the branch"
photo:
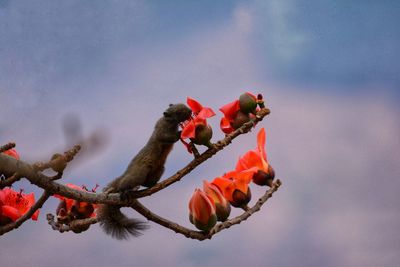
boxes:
[97,205,149,240]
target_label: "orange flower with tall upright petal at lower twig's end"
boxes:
[236,128,275,186]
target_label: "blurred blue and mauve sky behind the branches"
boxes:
[0,0,400,267]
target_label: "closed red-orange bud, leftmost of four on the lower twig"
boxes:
[189,188,217,232]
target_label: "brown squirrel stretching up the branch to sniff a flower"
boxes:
[97,104,192,240]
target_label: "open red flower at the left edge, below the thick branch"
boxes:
[0,187,39,225]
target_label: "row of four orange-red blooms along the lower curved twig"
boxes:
[189,128,275,231]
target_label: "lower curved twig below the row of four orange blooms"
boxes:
[131,179,282,241]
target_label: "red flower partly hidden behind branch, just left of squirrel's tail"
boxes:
[54,184,97,222]
